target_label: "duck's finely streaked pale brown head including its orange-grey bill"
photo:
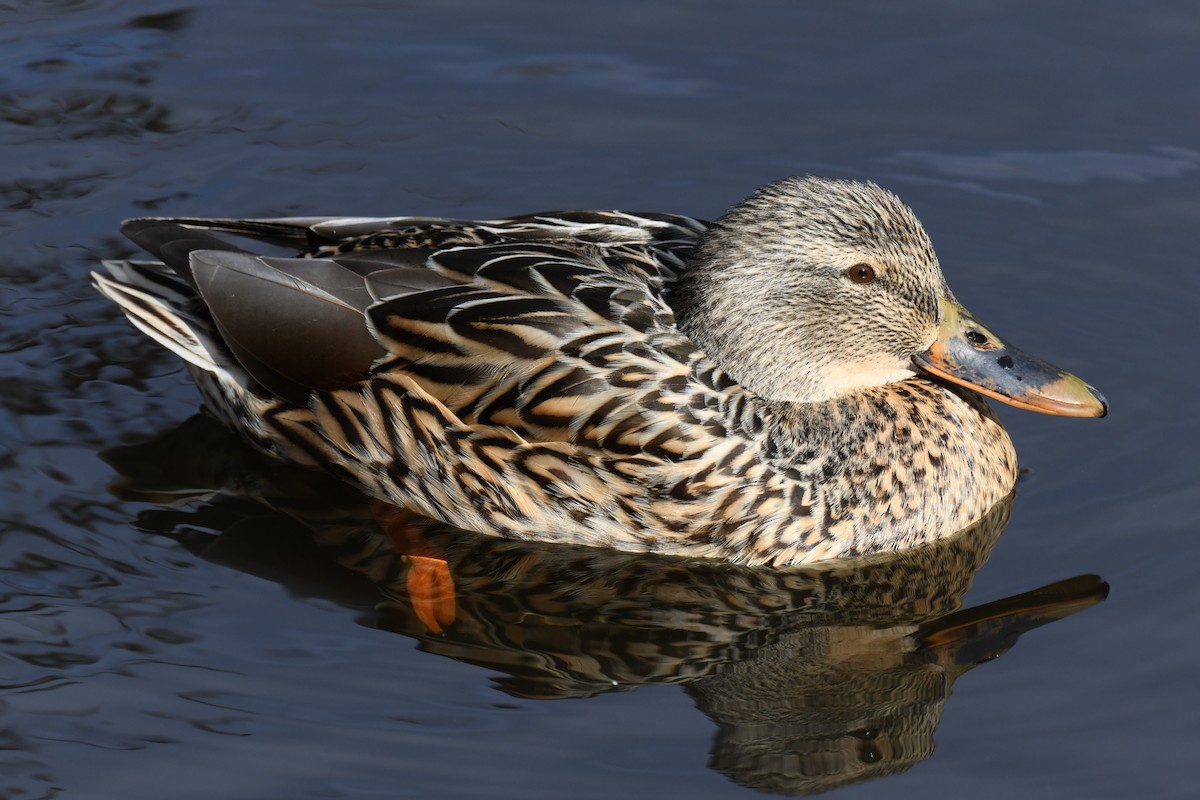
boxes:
[672,178,1108,416]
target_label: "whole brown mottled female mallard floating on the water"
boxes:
[96,178,1105,565]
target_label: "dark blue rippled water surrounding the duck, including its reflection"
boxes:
[0,0,1200,798]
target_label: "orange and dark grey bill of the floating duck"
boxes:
[912,297,1109,416]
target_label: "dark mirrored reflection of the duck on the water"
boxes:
[104,415,1108,794]
